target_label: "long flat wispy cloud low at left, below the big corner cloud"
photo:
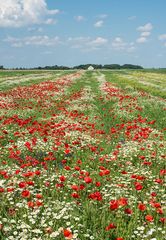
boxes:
[4,35,60,47]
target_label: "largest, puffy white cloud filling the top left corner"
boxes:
[0,0,60,27]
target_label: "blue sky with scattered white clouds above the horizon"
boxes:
[0,0,166,67]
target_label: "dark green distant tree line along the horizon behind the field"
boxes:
[0,64,143,70]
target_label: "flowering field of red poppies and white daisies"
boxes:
[0,70,166,240]
